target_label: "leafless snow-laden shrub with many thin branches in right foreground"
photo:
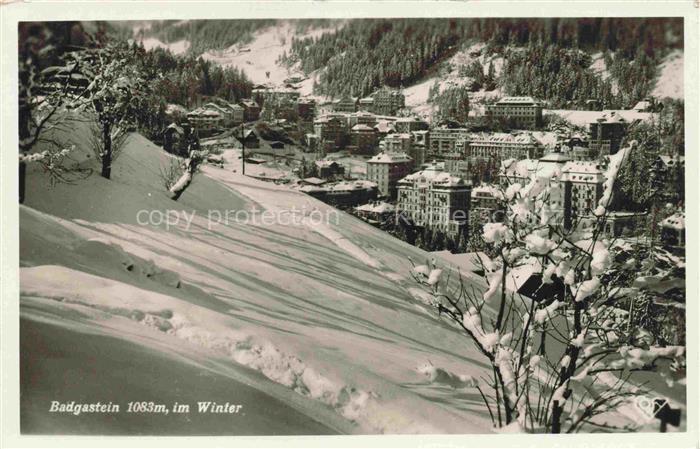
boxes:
[412,142,685,433]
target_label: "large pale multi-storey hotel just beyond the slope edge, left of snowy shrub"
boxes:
[397,165,471,234]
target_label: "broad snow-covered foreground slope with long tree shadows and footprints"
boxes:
[20,121,490,433]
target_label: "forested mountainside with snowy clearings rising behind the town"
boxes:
[98,18,683,114]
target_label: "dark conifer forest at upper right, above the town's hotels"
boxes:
[286,18,683,105]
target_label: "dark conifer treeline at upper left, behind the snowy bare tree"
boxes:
[18,22,253,144]
